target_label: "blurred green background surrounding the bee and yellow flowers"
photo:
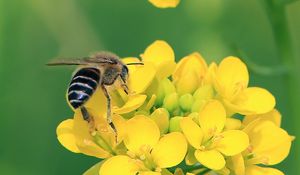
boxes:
[0,0,300,175]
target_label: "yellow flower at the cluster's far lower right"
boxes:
[228,110,294,175]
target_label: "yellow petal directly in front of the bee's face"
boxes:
[128,63,156,94]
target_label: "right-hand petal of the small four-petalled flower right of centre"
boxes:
[216,130,249,156]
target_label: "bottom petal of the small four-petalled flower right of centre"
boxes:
[195,150,225,170]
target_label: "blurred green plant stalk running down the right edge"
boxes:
[261,0,300,174]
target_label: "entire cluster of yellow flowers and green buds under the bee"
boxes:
[57,40,293,175]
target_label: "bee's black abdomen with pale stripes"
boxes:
[68,68,100,109]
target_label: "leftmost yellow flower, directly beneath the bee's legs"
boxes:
[57,79,146,158]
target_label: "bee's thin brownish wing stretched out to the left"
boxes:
[46,57,114,66]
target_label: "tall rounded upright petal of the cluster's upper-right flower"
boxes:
[215,56,249,99]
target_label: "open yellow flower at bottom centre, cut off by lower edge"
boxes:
[100,115,187,175]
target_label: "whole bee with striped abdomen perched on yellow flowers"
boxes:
[47,52,143,133]
